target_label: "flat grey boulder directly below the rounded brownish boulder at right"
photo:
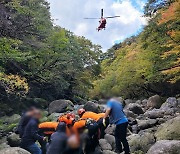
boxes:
[144,109,165,119]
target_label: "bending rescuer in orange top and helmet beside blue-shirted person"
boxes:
[78,108,109,138]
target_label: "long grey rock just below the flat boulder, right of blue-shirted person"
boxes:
[138,119,158,130]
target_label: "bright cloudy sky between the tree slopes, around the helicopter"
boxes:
[48,0,146,51]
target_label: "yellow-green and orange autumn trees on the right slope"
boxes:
[91,0,180,98]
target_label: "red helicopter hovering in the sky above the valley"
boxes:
[84,9,120,32]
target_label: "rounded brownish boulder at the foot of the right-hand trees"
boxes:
[147,95,162,109]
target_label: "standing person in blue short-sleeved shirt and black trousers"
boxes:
[104,98,130,154]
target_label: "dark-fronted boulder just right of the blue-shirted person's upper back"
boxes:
[126,103,144,115]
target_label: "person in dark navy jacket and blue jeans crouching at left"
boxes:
[21,109,45,154]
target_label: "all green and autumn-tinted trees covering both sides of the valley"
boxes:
[0,0,180,114]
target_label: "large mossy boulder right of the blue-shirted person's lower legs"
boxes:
[128,132,156,153]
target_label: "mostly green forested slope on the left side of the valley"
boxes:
[0,0,101,112]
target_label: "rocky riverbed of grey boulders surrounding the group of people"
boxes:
[0,95,180,154]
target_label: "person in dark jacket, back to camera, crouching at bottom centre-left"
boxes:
[47,122,67,154]
